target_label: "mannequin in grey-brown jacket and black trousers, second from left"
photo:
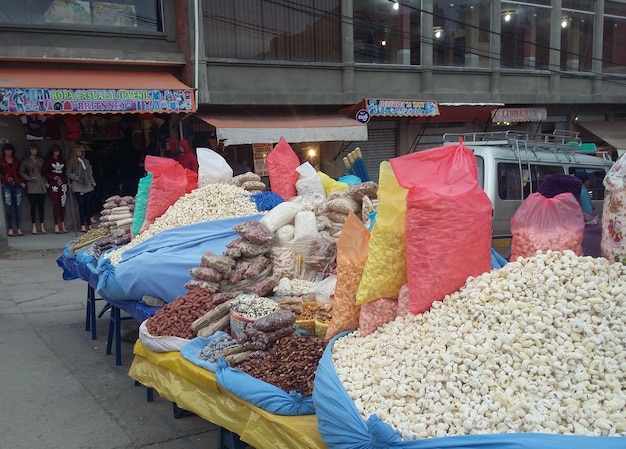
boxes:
[19,143,48,234]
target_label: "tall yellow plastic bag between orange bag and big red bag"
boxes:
[356,161,408,305]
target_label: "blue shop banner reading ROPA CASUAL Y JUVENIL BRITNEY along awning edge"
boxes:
[0,87,193,114]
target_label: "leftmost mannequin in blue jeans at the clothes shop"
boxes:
[0,143,25,237]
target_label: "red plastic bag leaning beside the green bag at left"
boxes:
[142,155,187,230]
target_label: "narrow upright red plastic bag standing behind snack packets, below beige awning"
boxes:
[266,137,300,201]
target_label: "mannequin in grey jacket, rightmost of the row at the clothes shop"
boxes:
[67,145,96,232]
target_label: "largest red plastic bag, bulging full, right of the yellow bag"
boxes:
[390,142,492,314]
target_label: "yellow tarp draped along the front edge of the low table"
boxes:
[128,340,327,449]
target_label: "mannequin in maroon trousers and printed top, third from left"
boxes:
[43,144,68,234]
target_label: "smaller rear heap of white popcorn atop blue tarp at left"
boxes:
[105,184,258,266]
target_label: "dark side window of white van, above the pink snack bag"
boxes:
[498,163,564,201]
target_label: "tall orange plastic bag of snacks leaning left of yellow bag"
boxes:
[325,212,370,340]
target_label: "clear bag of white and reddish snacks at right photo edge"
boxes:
[600,155,626,264]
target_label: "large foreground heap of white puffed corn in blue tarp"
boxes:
[313,250,626,448]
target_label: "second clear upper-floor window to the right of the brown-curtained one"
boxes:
[432,0,491,67]
